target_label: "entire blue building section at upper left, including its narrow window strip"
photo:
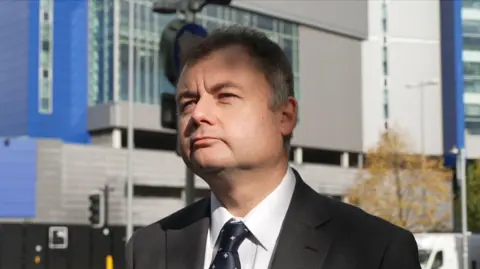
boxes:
[0,0,89,143]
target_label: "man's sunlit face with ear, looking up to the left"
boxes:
[177,47,297,174]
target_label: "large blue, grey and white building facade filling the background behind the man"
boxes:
[0,0,472,225]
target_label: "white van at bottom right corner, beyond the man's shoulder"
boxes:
[415,233,480,269]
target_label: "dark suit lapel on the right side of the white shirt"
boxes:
[271,171,334,269]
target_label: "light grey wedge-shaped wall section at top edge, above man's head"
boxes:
[232,0,369,39]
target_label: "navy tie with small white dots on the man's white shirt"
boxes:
[210,221,249,269]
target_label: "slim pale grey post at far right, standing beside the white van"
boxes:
[457,148,469,269]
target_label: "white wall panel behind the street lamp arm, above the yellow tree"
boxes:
[389,41,443,155]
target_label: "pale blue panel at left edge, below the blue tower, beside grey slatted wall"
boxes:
[0,138,37,218]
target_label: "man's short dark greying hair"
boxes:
[182,26,295,147]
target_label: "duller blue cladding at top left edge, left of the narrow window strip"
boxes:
[0,0,29,136]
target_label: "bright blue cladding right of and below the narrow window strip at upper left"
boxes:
[30,0,89,143]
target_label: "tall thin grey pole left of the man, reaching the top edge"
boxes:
[126,0,134,242]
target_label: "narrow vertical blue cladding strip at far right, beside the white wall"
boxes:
[441,1,465,166]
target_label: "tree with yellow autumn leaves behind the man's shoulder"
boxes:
[347,127,452,232]
